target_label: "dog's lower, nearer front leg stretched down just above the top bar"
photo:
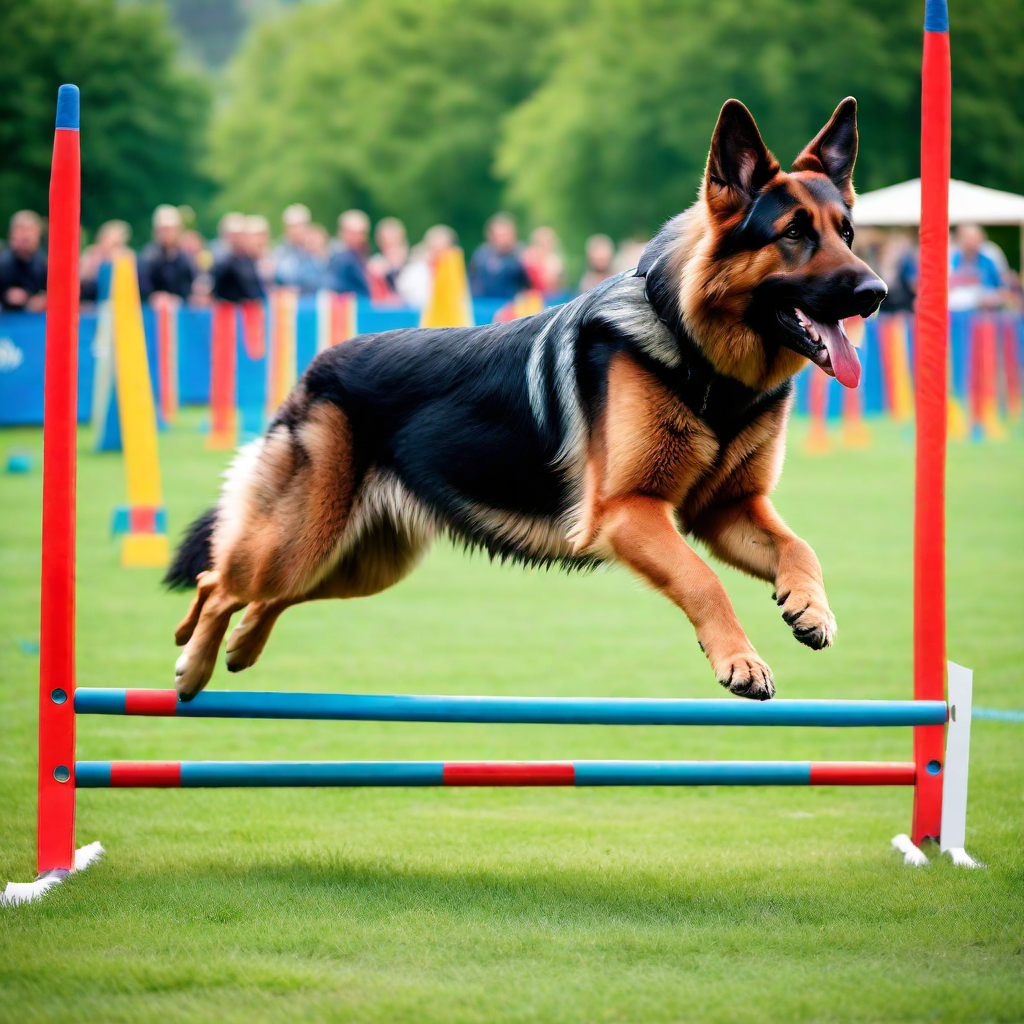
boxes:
[599,495,775,700]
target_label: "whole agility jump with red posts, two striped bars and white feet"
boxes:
[0,0,977,903]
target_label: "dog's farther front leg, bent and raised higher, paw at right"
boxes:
[692,495,836,650]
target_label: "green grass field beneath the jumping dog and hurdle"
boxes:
[0,415,1024,1024]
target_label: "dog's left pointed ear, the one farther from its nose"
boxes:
[703,99,779,212]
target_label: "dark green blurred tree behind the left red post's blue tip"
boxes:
[0,0,210,242]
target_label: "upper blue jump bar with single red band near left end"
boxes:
[75,686,946,726]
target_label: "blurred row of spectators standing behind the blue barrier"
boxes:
[0,203,1022,312]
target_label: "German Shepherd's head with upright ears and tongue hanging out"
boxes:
[638,97,886,387]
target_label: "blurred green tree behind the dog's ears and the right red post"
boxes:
[498,0,1024,254]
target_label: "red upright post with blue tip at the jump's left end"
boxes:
[38,85,81,873]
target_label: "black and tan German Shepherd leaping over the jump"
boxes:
[166,98,886,700]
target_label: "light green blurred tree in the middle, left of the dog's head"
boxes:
[210,0,569,244]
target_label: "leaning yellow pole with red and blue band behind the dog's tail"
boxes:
[111,255,170,568]
